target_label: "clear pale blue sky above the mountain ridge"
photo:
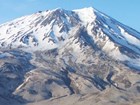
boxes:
[0,0,140,32]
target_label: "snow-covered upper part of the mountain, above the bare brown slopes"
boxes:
[0,7,140,68]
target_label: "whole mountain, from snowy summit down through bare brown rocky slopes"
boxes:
[0,7,140,105]
